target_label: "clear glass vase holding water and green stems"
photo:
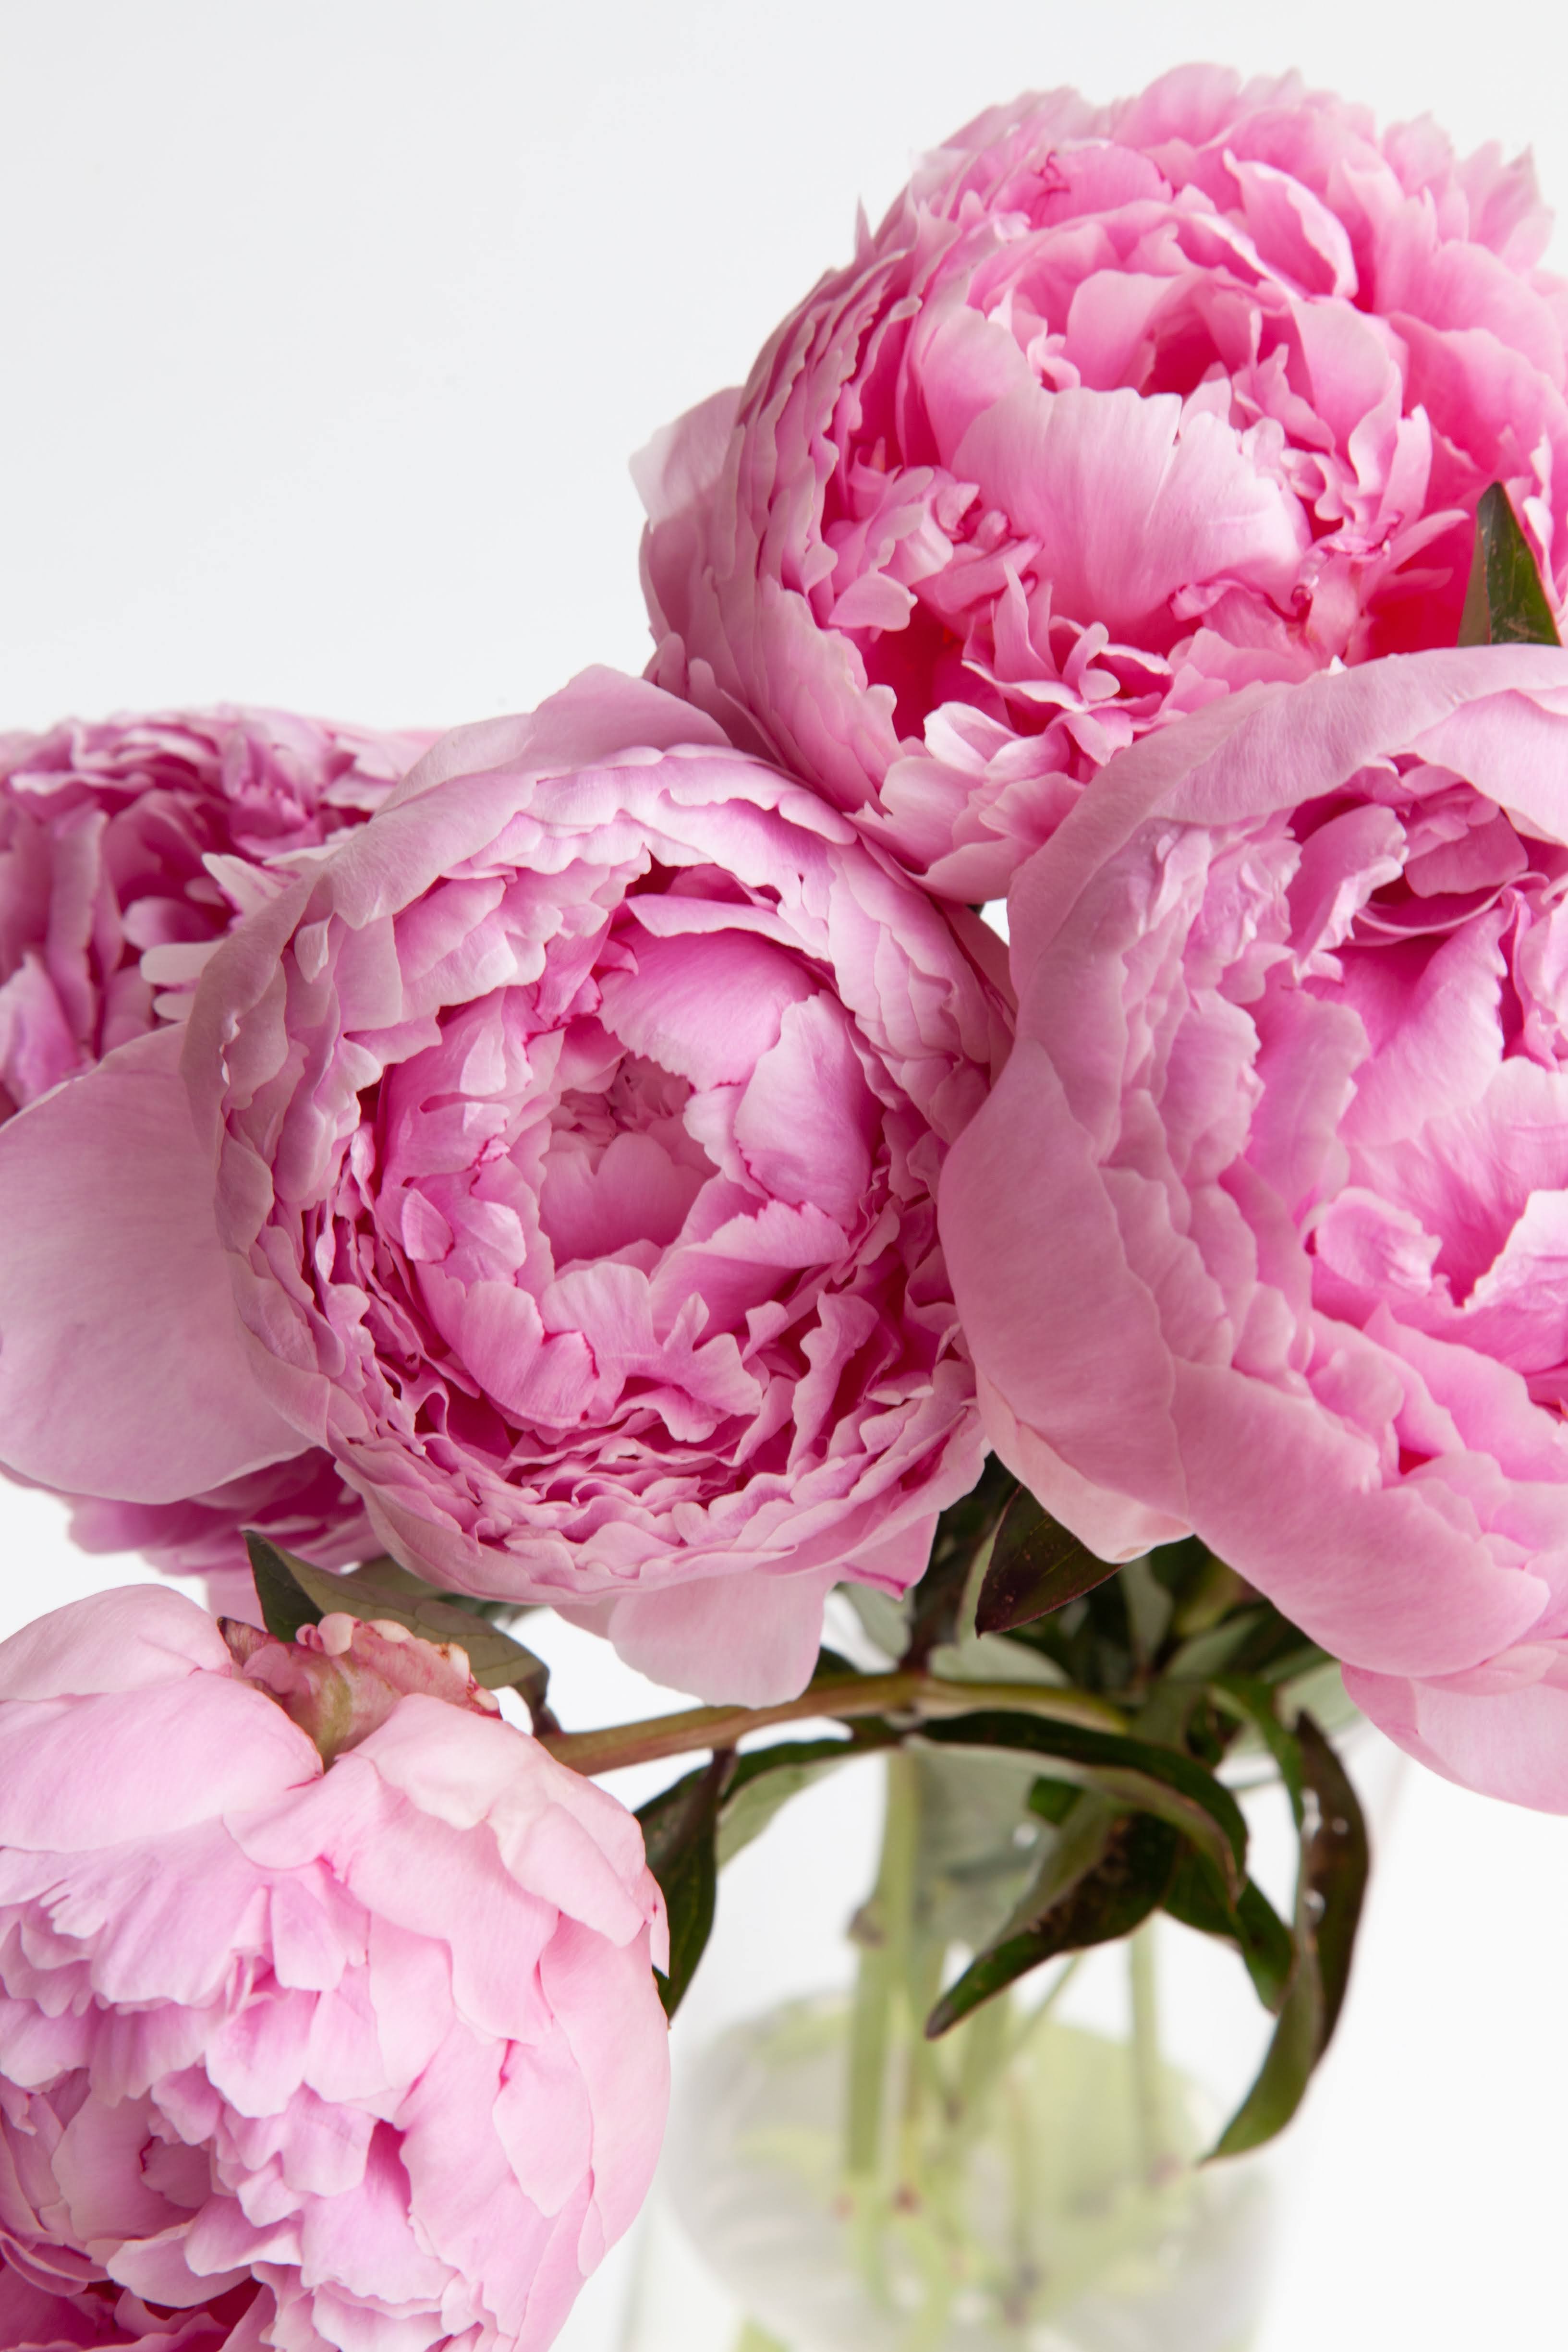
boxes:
[618,1747,1274,2352]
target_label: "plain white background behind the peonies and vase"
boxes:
[0,0,1568,2352]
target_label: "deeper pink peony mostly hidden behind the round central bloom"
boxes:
[0,710,433,1583]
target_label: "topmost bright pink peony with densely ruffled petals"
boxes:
[639,66,1568,898]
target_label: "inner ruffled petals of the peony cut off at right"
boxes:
[1307,762,1568,1402]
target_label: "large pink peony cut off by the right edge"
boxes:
[943,647,1568,1811]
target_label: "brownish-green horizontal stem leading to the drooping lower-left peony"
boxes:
[538,1672,1126,1773]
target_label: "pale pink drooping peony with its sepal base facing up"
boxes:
[0,1585,668,2352]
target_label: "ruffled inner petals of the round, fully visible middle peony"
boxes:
[334,891,888,1491]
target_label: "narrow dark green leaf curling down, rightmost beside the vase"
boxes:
[1211,1715,1368,2157]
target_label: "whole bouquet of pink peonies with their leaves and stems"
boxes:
[0,68,1568,2352]
